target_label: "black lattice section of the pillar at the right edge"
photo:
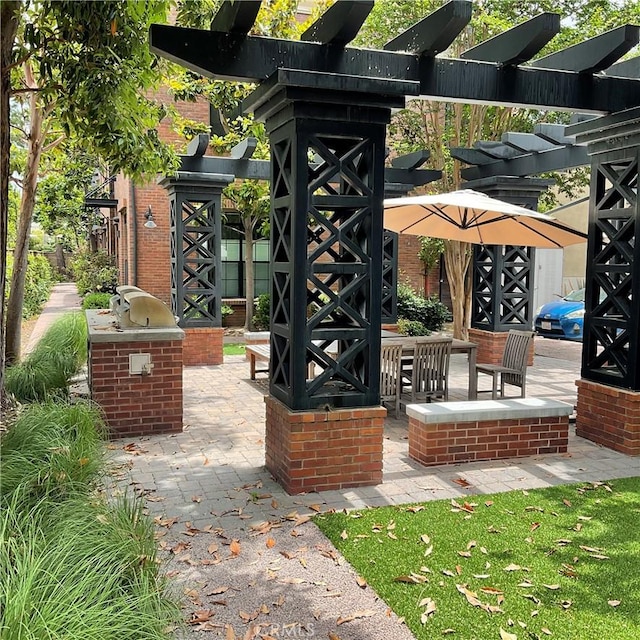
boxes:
[582,147,640,391]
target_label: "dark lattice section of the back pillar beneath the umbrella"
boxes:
[471,245,534,331]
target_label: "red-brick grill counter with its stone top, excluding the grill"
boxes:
[86,310,184,437]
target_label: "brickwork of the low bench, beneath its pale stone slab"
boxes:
[409,416,569,466]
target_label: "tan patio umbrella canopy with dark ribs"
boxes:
[384,189,587,249]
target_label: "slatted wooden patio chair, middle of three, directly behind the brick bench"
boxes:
[402,338,452,402]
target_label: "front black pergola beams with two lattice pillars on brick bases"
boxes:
[151,0,640,492]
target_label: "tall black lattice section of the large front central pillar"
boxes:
[270,121,384,409]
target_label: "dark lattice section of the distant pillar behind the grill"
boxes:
[171,192,222,327]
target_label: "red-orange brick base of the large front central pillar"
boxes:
[265,396,387,494]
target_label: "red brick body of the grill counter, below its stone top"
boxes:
[89,340,182,437]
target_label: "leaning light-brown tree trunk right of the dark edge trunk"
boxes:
[5,63,44,363]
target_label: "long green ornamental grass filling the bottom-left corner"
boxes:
[0,403,179,640]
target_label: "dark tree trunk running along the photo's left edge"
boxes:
[0,0,20,400]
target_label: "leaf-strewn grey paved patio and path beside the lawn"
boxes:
[110,348,640,640]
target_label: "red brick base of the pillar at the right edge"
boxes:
[576,379,640,456]
